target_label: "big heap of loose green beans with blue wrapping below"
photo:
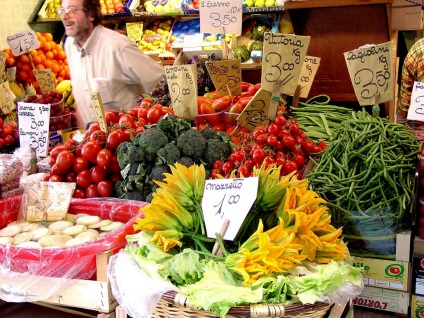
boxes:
[308,111,421,258]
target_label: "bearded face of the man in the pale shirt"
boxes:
[61,0,93,42]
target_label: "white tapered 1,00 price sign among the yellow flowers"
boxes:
[202,177,258,240]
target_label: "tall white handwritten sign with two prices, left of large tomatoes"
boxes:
[18,102,50,157]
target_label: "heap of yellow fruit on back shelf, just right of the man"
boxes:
[138,19,173,53]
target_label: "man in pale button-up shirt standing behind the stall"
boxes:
[57,0,164,125]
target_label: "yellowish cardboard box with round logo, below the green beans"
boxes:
[352,257,410,291]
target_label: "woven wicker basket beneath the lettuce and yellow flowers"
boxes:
[152,292,330,318]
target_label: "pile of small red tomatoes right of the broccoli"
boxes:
[211,115,327,179]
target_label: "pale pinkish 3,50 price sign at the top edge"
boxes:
[199,0,243,34]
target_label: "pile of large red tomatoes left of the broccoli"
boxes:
[43,100,169,198]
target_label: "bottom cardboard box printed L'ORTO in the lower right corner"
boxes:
[353,286,409,314]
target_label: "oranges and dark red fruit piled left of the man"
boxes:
[2,32,70,94]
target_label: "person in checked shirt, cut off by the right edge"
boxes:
[397,38,424,129]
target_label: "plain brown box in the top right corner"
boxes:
[391,5,424,30]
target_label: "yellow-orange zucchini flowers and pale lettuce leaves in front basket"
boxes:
[126,163,362,317]
